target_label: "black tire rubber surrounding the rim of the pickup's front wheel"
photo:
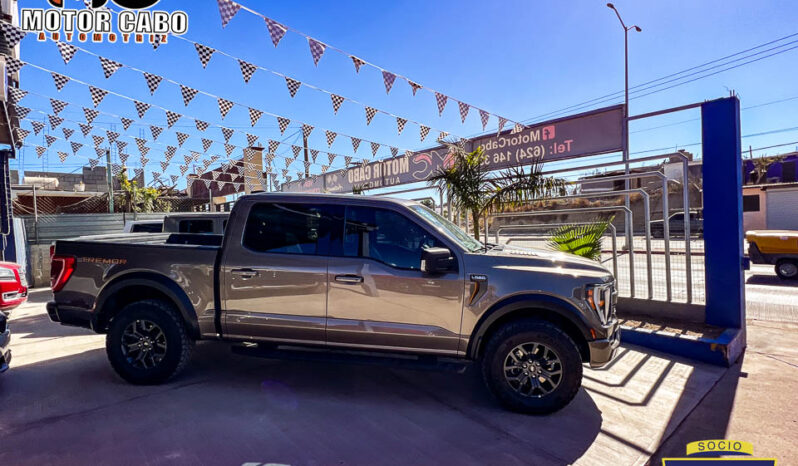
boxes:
[481,319,582,414]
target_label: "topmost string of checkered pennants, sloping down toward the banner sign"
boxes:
[209,0,523,132]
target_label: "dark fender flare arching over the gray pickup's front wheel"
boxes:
[466,293,591,359]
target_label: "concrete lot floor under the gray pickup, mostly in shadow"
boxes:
[0,291,726,465]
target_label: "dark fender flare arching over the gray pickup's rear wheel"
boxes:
[93,272,200,338]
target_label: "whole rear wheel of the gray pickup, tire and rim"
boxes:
[105,299,193,385]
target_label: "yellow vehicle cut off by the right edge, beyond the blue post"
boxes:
[745,230,798,280]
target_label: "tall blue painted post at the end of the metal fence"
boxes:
[701,97,745,328]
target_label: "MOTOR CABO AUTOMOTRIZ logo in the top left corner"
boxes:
[20,0,188,44]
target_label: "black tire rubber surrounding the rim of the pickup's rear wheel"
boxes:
[105,299,194,385]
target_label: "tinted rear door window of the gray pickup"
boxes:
[243,204,329,255]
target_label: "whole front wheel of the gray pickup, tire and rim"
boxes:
[482,320,582,414]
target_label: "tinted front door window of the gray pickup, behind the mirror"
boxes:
[344,207,445,270]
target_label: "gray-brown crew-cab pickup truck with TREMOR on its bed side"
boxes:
[47,193,619,413]
